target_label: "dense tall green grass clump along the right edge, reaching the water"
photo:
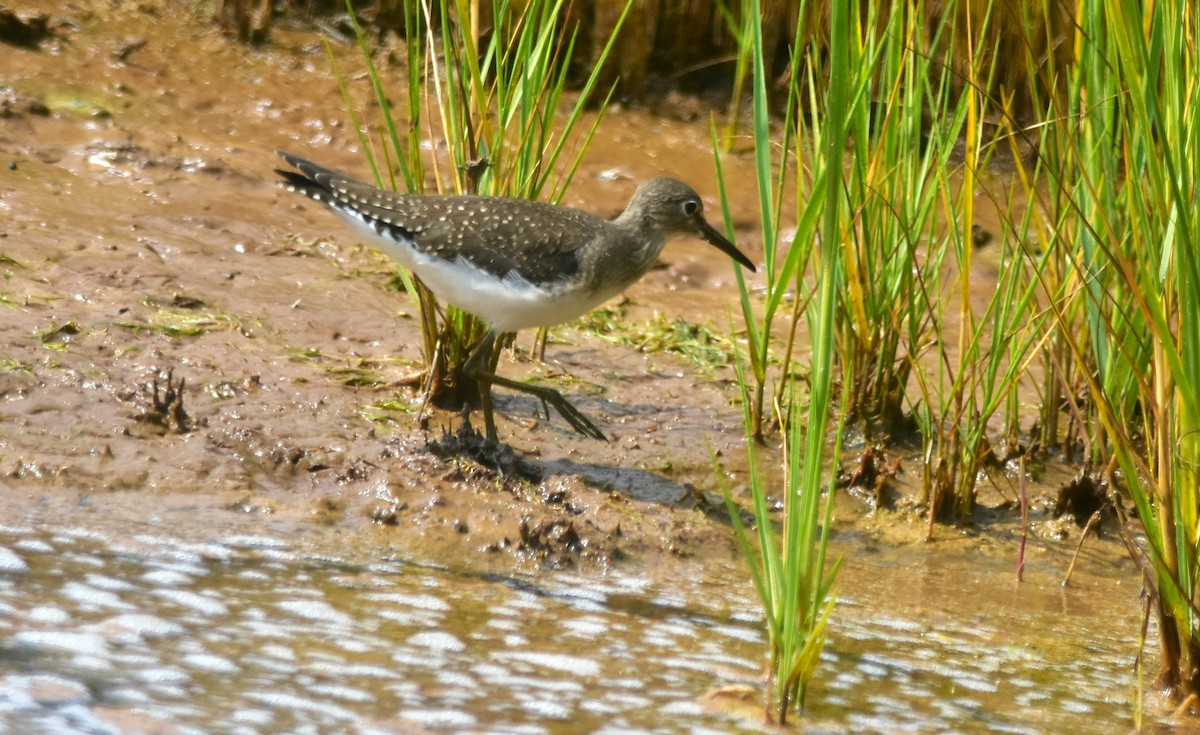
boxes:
[1045,0,1200,712]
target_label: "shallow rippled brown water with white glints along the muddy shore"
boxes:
[0,527,1138,734]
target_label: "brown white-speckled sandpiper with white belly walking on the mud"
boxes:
[275,151,755,444]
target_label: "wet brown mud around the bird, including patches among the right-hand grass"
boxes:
[0,0,1156,730]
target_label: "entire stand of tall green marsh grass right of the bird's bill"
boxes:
[713,0,1200,717]
